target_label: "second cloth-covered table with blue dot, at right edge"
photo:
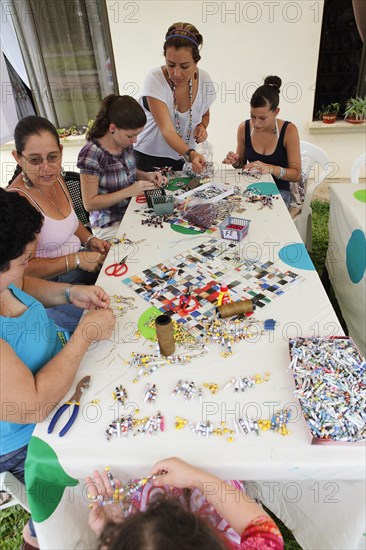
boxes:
[326,183,366,356]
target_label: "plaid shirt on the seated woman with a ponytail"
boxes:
[77,140,136,231]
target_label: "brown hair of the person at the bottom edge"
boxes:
[99,494,229,550]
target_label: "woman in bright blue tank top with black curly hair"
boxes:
[0,189,115,545]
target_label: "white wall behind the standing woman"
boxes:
[107,0,365,178]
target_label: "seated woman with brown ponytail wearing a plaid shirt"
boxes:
[77,94,164,239]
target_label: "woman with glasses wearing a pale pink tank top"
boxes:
[7,116,110,330]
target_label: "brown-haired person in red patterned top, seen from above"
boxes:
[86,458,283,550]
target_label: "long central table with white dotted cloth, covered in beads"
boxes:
[26,173,365,549]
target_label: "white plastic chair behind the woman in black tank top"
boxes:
[294,141,333,251]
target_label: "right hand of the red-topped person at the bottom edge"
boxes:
[150,457,203,489]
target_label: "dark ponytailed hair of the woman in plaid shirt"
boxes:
[86,94,146,140]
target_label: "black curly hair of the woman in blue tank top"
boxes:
[0,189,43,272]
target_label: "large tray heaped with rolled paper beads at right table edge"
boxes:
[289,336,366,445]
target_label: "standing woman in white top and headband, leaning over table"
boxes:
[135,23,215,173]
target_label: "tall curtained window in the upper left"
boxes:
[12,0,118,128]
